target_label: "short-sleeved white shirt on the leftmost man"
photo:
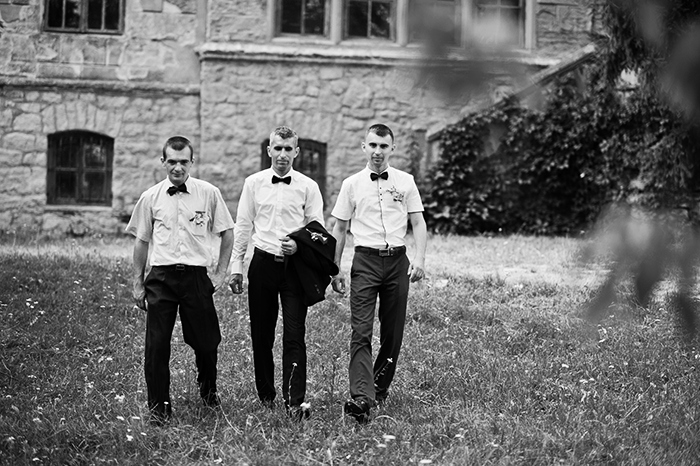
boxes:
[126,176,233,267]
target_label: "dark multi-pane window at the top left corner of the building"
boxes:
[44,0,124,34]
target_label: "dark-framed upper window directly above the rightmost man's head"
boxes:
[345,0,396,39]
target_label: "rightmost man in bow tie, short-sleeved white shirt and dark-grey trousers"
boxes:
[332,124,427,423]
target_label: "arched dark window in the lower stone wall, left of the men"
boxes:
[46,131,114,206]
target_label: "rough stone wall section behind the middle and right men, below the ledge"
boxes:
[201,54,462,214]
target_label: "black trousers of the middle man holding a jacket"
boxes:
[248,249,307,406]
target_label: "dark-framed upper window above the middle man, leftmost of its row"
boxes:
[279,0,330,36]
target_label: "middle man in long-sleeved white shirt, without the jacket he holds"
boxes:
[231,126,324,421]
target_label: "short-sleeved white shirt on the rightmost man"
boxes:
[331,167,423,248]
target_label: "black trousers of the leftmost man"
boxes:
[144,266,221,413]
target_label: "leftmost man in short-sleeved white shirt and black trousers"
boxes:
[126,136,233,425]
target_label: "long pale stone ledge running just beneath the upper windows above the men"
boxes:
[196,41,559,67]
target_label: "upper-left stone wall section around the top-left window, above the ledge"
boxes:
[0,0,203,83]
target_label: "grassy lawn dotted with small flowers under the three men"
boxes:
[0,237,700,465]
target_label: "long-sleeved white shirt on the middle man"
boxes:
[230,168,324,273]
